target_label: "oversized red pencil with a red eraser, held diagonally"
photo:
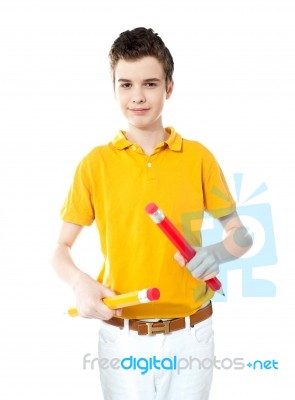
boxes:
[145,203,224,296]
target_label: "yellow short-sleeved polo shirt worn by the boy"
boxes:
[61,127,235,318]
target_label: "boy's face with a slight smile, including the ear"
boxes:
[114,56,173,129]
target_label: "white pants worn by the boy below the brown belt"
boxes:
[99,317,214,400]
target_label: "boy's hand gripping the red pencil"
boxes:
[174,246,219,281]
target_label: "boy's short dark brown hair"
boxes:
[109,28,174,87]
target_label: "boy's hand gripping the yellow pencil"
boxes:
[73,272,122,320]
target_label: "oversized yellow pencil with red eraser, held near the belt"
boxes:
[68,288,160,317]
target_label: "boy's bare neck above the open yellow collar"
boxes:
[126,120,169,155]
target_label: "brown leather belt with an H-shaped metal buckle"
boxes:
[104,302,213,336]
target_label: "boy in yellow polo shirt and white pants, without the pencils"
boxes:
[52,28,251,400]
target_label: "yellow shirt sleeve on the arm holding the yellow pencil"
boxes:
[61,159,95,226]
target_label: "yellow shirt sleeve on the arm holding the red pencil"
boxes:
[203,151,236,218]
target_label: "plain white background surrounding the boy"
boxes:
[0,0,295,400]
